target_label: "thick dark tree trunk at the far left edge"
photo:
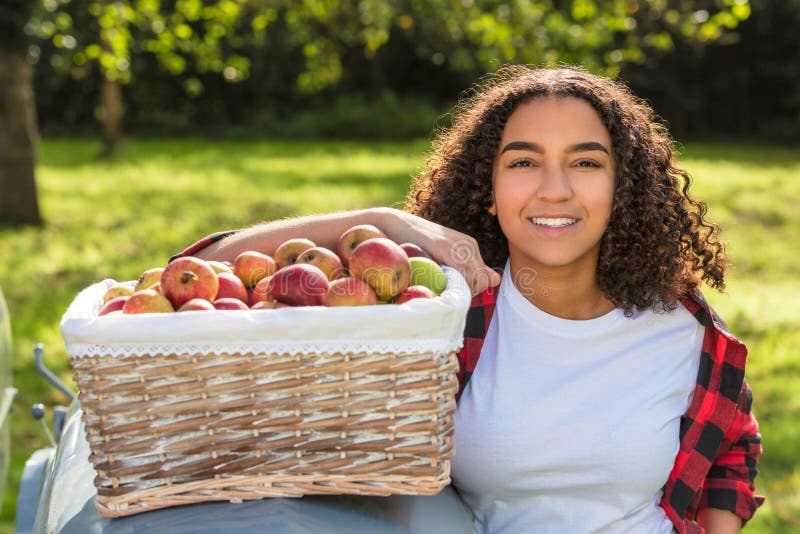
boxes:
[0,49,42,224]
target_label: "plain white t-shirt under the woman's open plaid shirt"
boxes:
[452,266,703,534]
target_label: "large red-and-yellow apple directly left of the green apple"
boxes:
[350,237,411,300]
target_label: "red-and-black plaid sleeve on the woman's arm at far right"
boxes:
[698,380,764,524]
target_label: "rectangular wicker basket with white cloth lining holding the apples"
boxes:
[62,269,476,517]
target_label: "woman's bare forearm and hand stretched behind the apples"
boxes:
[194,208,500,294]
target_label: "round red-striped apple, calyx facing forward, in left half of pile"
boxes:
[161,256,219,308]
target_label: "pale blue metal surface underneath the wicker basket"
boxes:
[25,402,474,534]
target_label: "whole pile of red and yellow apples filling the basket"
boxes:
[99,224,447,315]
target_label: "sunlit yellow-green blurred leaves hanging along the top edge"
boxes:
[26,0,750,84]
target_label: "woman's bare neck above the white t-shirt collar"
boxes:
[511,259,614,320]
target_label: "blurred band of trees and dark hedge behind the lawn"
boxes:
[7,0,800,142]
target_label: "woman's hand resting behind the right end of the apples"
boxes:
[376,208,501,295]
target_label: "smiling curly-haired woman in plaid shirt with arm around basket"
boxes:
[183,66,762,533]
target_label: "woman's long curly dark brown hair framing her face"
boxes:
[405,65,727,314]
